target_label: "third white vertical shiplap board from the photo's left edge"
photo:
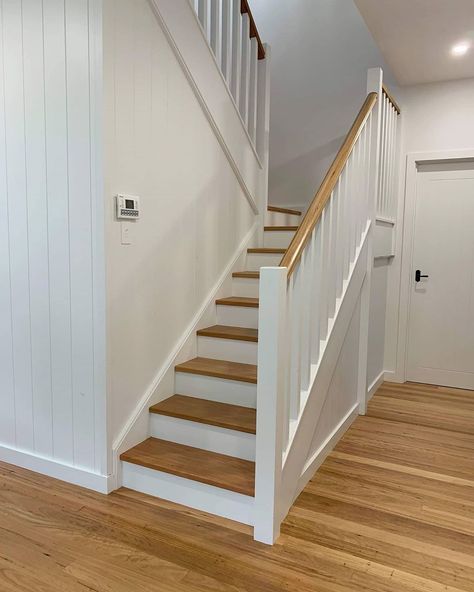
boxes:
[22,0,53,456]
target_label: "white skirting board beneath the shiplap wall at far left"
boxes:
[0,446,113,493]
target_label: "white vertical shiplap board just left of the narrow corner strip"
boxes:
[65,0,95,469]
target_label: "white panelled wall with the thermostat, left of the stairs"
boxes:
[104,0,261,448]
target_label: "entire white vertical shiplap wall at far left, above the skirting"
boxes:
[0,0,107,484]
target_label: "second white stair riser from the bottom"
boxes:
[150,413,255,461]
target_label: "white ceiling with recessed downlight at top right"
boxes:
[354,0,474,85]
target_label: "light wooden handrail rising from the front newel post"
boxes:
[280,92,377,278]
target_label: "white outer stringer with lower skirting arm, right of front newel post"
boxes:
[280,222,370,520]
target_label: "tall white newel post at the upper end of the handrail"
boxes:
[357,68,383,415]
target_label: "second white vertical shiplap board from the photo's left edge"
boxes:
[3,0,34,450]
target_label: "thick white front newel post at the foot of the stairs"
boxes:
[254,267,287,544]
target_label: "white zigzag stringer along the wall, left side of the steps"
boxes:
[110,218,260,491]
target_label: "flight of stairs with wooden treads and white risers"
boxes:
[120,207,301,524]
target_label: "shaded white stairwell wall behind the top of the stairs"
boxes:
[250,0,395,205]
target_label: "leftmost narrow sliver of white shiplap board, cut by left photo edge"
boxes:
[0,2,15,446]
